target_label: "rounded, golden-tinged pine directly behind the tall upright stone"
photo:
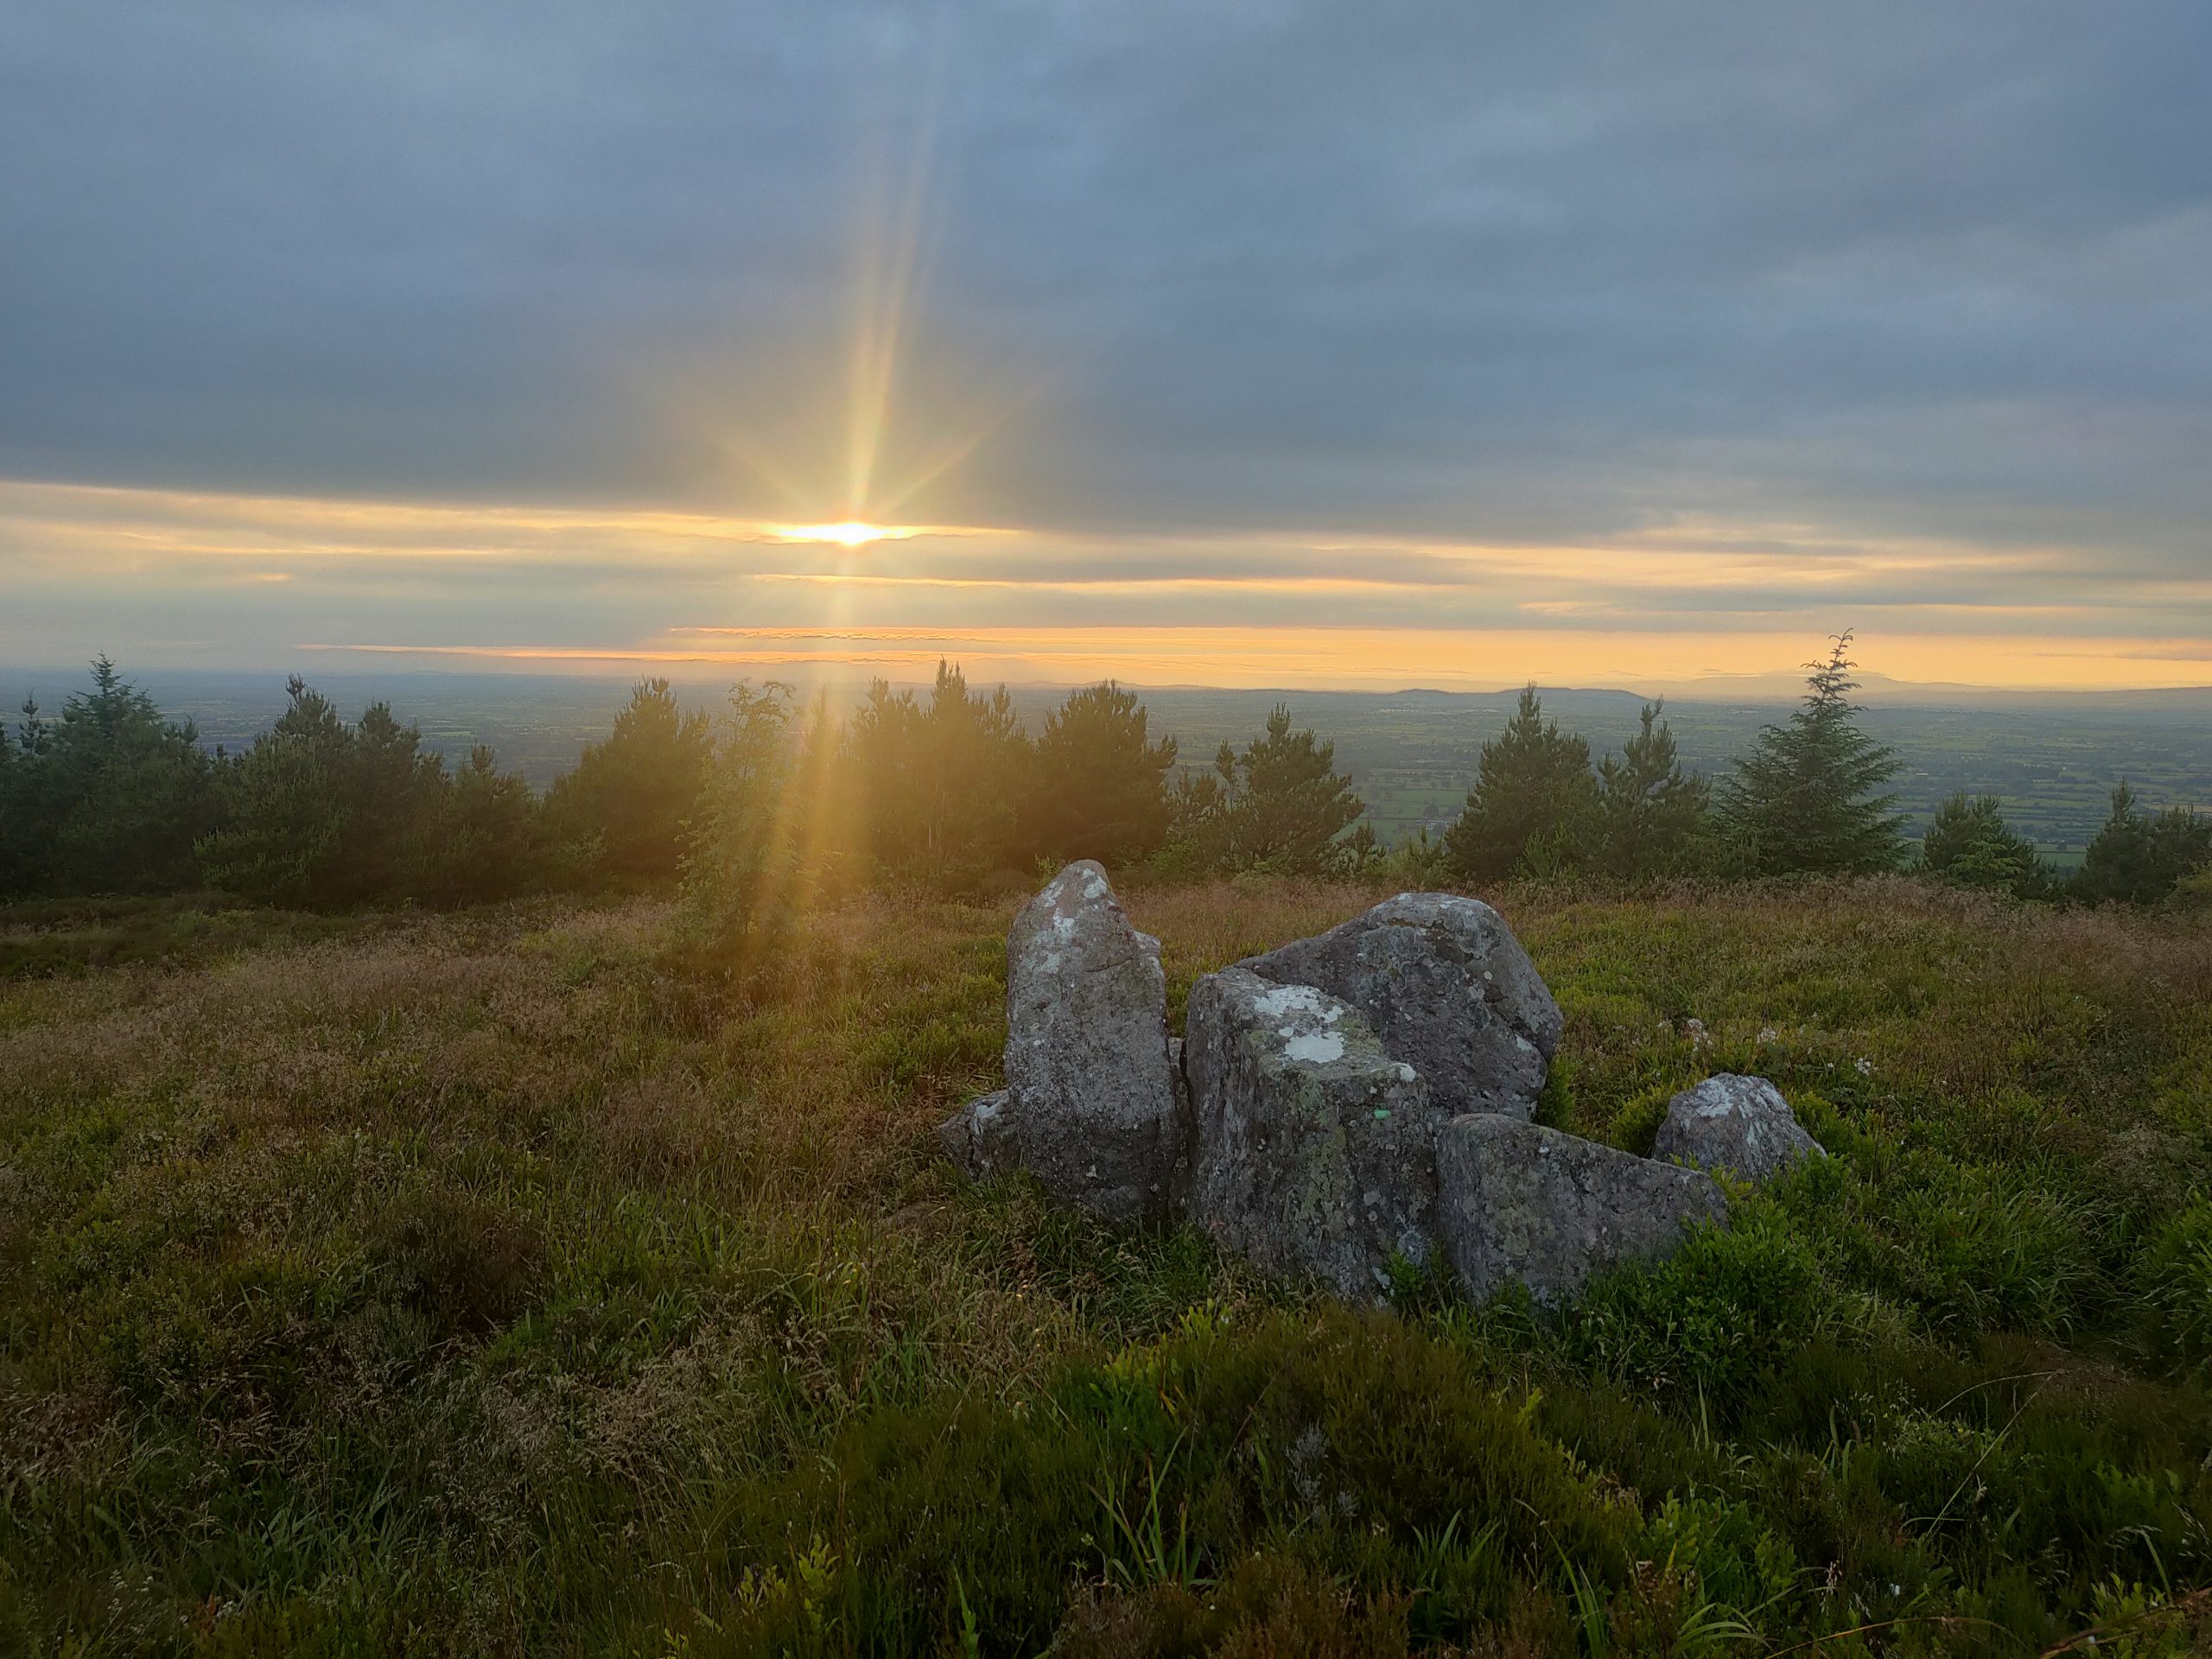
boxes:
[1022,679,1174,868]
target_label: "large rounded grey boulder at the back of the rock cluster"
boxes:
[1236,893,1560,1117]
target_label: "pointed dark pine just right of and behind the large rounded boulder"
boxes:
[1445,686,1597,880]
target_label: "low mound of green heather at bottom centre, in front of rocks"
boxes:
[708,1310,1626,1652]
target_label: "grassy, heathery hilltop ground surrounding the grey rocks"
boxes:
[0,878,2212,1659]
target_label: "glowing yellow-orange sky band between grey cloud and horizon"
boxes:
[17,480,2212,695]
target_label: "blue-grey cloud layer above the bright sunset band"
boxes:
[0,0,2212,559]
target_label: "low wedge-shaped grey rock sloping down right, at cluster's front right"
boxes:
[1435,1115,1727,1303]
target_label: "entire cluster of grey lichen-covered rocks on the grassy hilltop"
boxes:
[940,861,1821,1300]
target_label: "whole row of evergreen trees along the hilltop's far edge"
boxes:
[0,635,2212,927]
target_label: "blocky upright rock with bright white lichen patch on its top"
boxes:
[1184,969,1445,1300]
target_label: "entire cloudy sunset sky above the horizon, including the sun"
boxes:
[0,0,2212,686]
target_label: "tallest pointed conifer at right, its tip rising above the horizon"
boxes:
[1721,632,1904,876]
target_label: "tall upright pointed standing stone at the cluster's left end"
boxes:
[1002,858,1188,1224]
